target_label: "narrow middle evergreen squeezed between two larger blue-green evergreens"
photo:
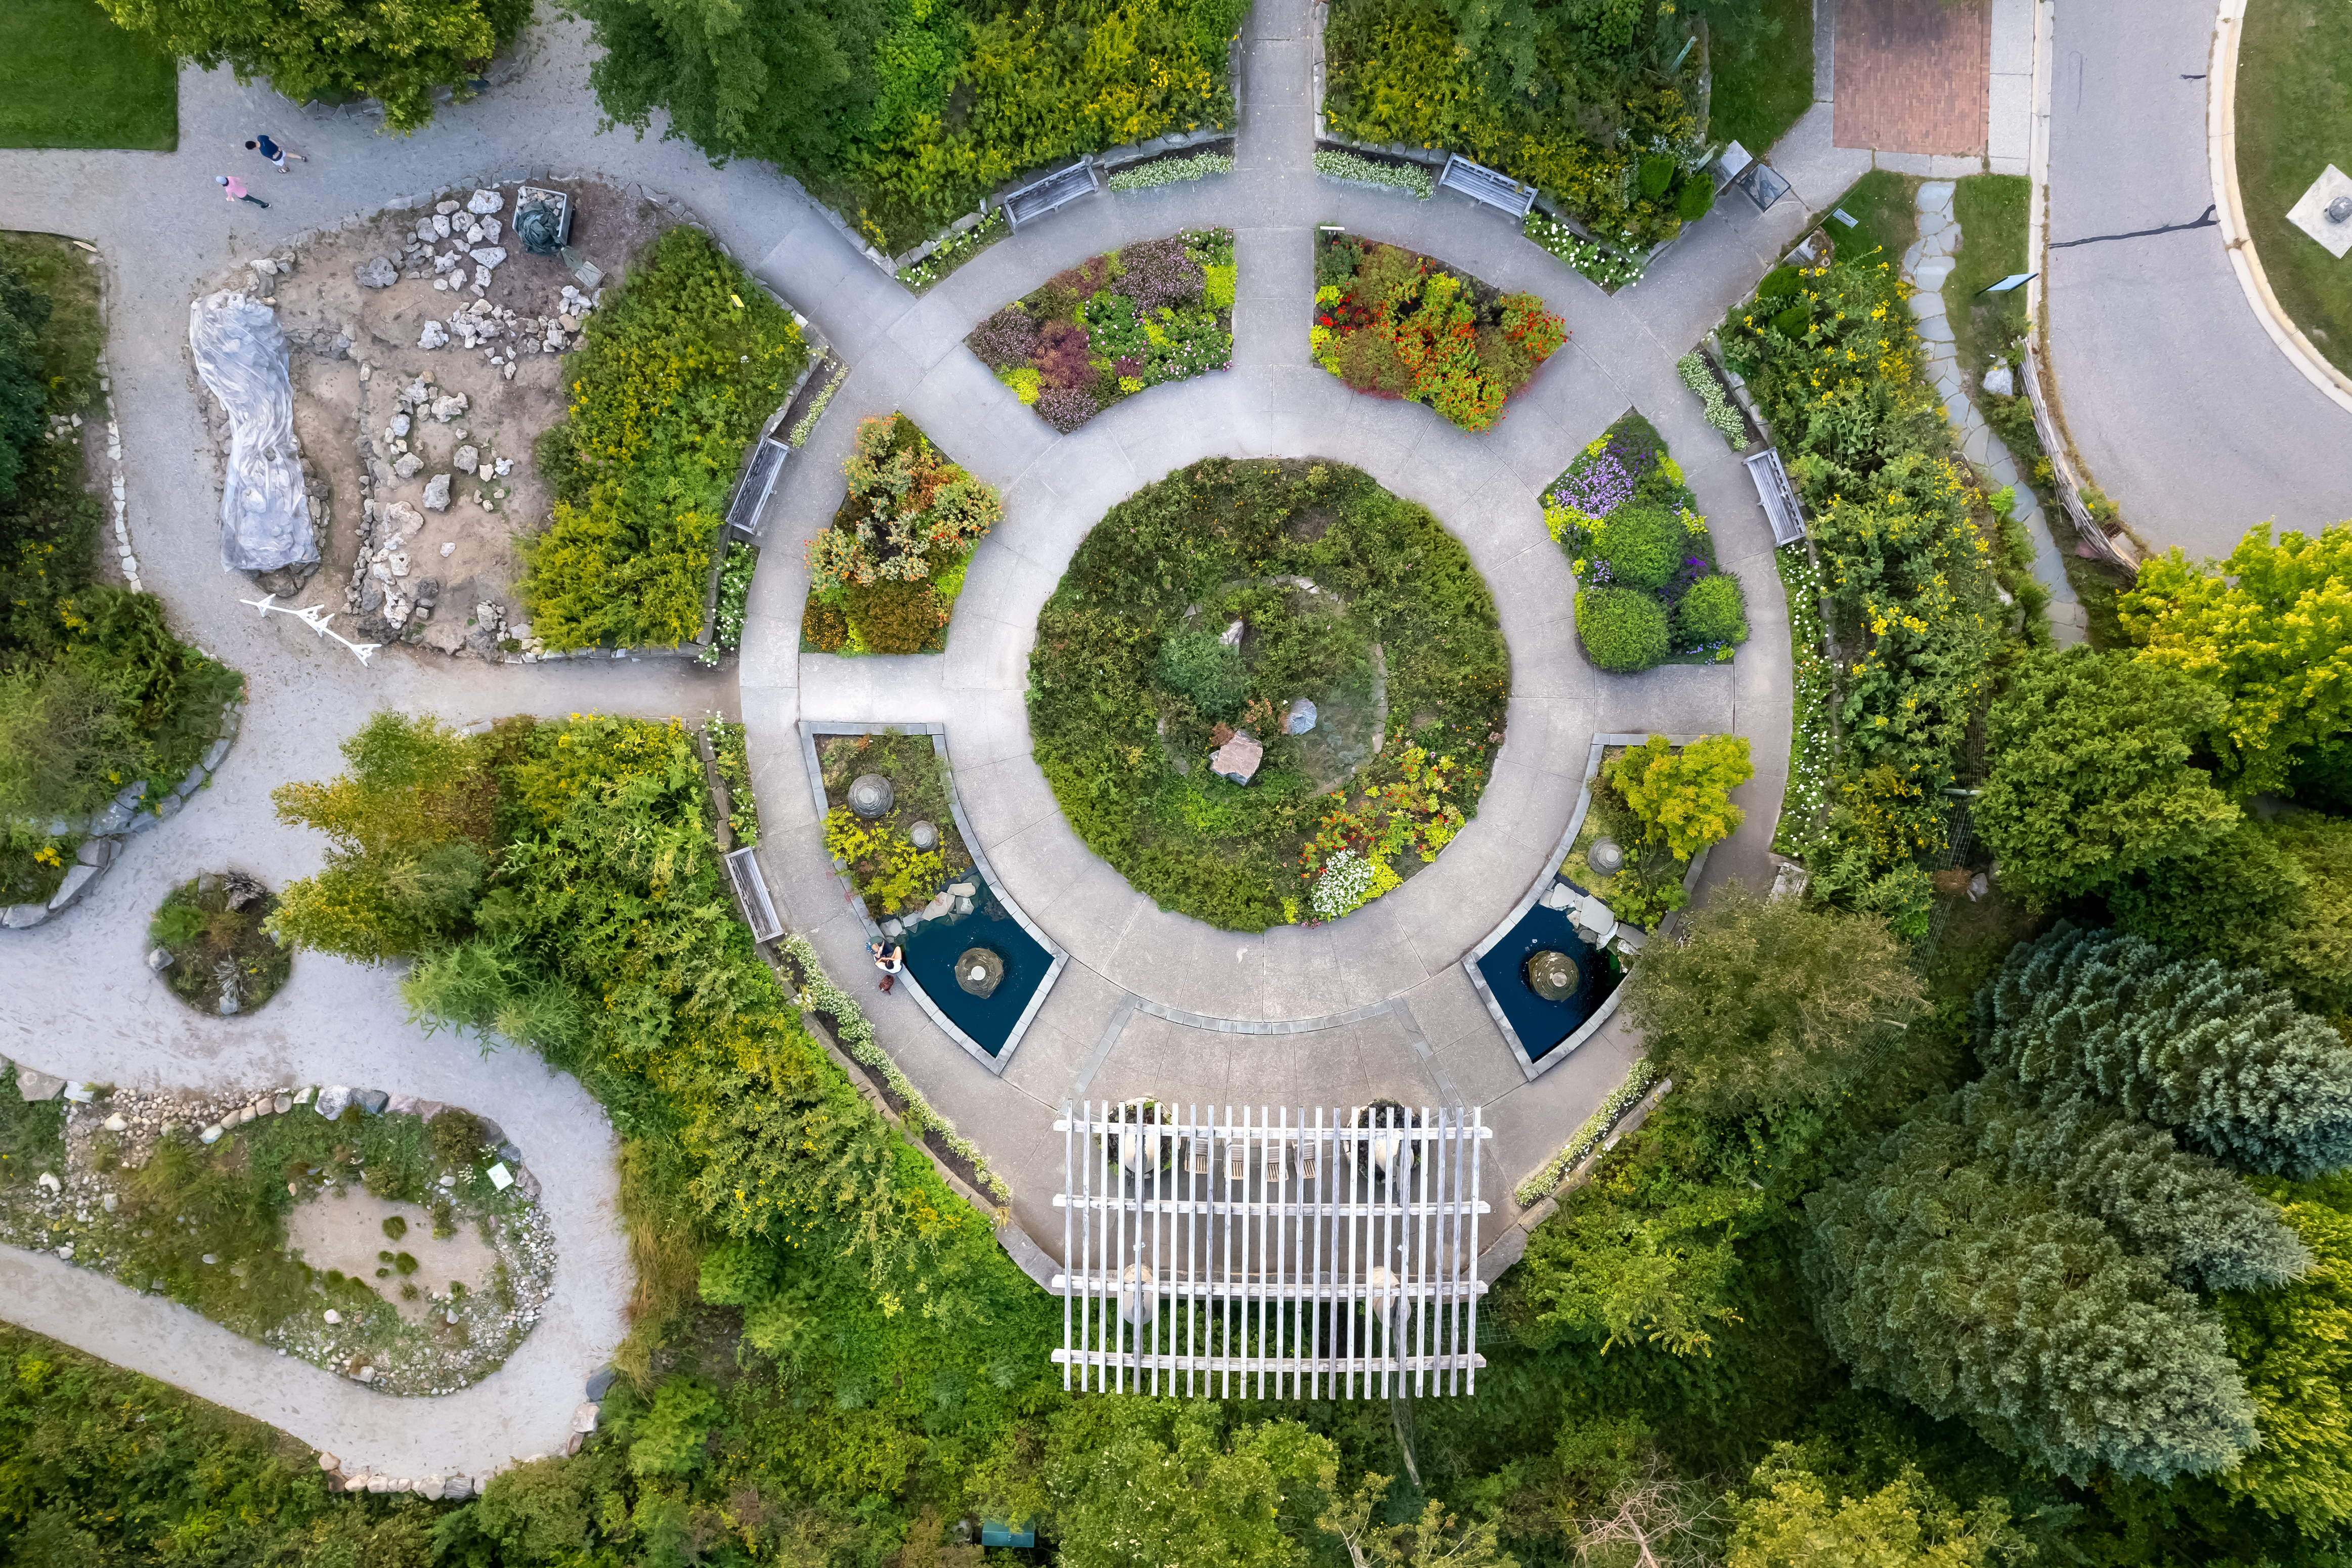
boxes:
[1952,1072,2312,1291]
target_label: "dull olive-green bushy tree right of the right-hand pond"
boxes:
[1625,882,1926,1110]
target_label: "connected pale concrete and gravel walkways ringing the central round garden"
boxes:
[0,0,1835,1474]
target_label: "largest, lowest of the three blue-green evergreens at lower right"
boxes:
[1804,1117,2255,1484]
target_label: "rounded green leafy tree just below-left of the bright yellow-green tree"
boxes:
[1976,646,2237,900]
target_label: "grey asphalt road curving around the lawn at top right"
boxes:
[2044,0,2352,555]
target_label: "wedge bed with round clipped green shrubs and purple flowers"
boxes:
[1543,411,1748,675]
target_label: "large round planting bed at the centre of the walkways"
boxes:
[1030,458,1510,931]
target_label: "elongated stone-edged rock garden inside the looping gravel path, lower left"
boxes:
[0,1065,555,1394]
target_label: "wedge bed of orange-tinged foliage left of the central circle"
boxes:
[800,414,1005,654]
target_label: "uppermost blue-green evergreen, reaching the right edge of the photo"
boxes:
[1976,922,2352,1175]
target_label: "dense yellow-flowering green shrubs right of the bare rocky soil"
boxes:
[515,228,809,651]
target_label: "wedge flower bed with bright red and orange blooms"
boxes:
[1308,233,1569,430]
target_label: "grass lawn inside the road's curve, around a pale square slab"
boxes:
[2237,0,2352,371]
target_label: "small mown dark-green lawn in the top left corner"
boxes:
[0,0,179,153]
